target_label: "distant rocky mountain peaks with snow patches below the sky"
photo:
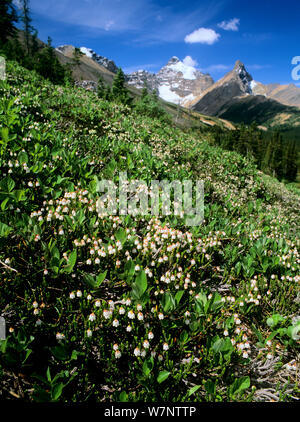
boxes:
[55,45,300,127]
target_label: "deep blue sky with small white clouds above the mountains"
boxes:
[15,0,300,84]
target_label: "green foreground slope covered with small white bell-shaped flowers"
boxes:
[0,64,299,401]
